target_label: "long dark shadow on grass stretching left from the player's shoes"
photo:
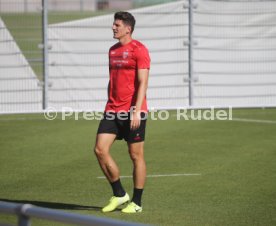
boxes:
[0,198,107,211]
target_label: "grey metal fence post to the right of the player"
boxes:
[188,0,194,106]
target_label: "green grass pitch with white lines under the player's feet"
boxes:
[0,108,276,226]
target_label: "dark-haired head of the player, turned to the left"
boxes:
[112,12,135,39]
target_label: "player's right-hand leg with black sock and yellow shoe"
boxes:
[122,142,146,213]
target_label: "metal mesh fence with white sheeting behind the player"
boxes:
[0,0,276,113]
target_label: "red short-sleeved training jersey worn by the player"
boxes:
[105,40,150,112]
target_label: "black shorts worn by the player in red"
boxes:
[97,113,147,143]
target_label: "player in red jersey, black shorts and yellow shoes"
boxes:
[95,12,150,213]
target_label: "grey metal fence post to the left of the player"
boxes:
[42,0,49,110]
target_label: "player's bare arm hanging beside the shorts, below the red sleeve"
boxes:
[130,69,149,130]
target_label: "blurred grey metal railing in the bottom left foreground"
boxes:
[0,201,147,226]
